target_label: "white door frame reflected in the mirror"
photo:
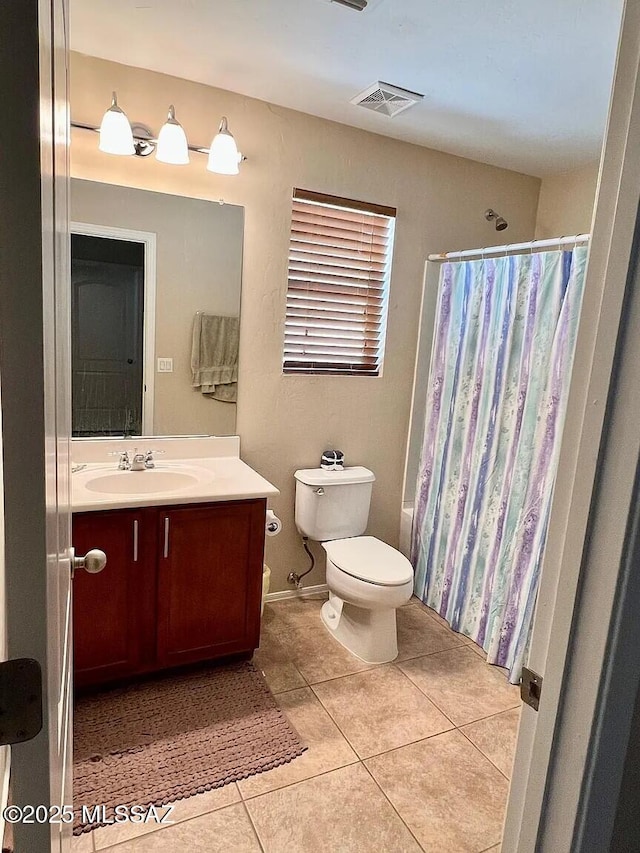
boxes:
[71,221,157,435]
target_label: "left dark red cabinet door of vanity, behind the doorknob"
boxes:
[73,510,155,686]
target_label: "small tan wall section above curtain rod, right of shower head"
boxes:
[536,161,600,240]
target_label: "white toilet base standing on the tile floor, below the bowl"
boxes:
[321,592,398,664]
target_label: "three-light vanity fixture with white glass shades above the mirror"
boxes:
[71,92,247,175]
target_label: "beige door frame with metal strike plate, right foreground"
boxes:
[502,0,640,853]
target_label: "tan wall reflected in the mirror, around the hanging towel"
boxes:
[71,180,244,435]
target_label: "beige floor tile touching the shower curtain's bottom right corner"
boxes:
[398,646,520,726]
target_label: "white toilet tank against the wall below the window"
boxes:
[294,466,375,542]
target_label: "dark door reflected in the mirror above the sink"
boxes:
[71,234,144,436]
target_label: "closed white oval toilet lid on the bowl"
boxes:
[322,536,413,586]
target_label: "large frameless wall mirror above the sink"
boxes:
[71,179,244,437]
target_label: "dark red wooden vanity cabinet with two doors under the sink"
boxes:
[73,499,266,687]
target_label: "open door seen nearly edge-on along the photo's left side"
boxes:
[0,0,72,853]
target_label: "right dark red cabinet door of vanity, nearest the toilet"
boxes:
[158,500,266,666]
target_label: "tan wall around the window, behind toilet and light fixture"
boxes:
[71,55,540,590]
